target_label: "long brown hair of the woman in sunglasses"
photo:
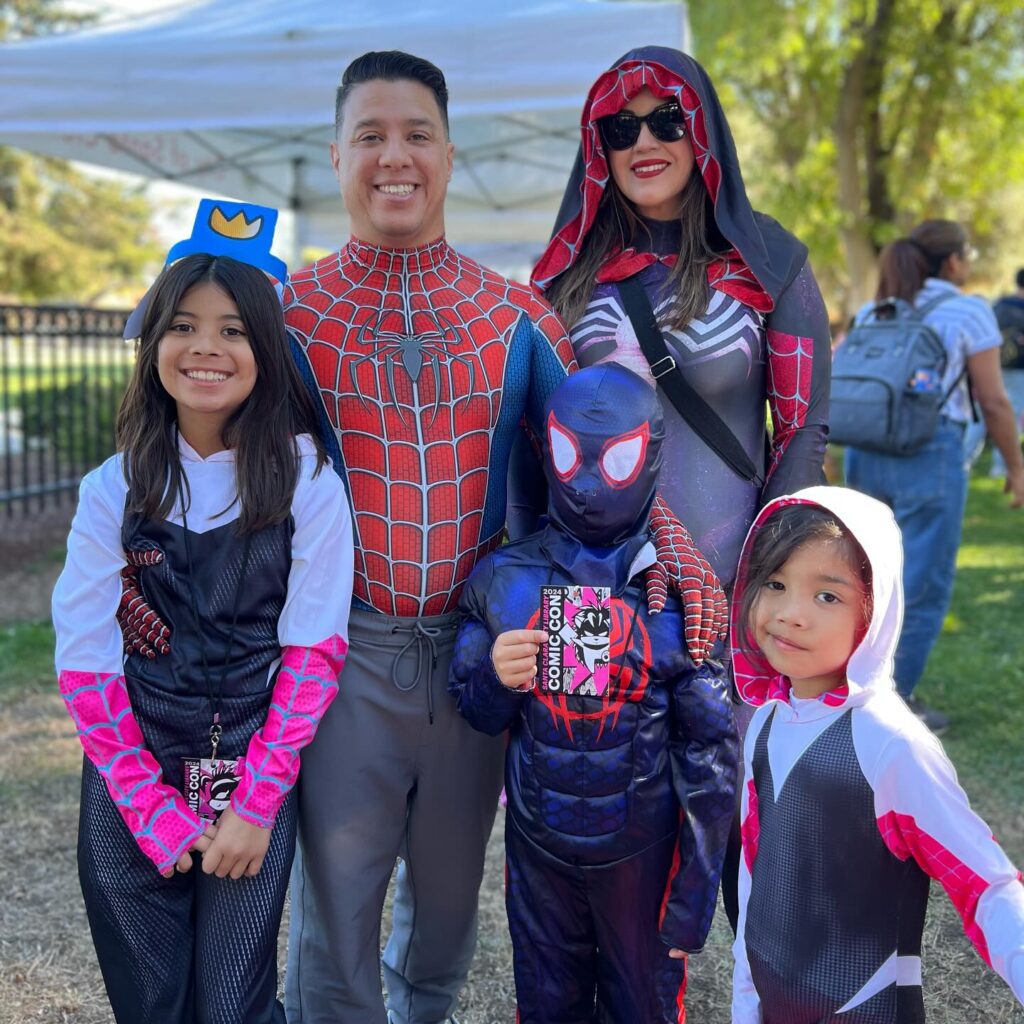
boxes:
[547,167,728,330]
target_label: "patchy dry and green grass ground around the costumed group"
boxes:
[0,467,1024,1024]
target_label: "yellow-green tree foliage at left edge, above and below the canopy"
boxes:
[0,0,160,303]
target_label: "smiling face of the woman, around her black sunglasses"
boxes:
[607,88,694,220]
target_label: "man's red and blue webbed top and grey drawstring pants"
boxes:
[285,239,574,1024]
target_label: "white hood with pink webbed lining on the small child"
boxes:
[730,487,903,713]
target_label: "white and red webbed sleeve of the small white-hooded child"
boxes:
[874,730,1024,1002]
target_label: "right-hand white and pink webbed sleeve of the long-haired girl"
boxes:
[231,458,352,828]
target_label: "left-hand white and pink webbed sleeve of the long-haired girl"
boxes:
[52,459,203,870]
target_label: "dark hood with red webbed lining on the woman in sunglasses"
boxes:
[531,46,807,313]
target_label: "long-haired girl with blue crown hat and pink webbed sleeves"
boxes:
[53,200,352,1024]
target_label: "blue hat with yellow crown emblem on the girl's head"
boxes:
[124,199,288,339]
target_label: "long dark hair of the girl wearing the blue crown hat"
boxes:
[116,253,327,532]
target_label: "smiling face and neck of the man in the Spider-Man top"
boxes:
[331,79,454,248]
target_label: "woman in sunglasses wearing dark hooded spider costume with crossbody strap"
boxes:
[532,46,831,927]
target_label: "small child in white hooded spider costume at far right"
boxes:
[732,487,1024,1024]
